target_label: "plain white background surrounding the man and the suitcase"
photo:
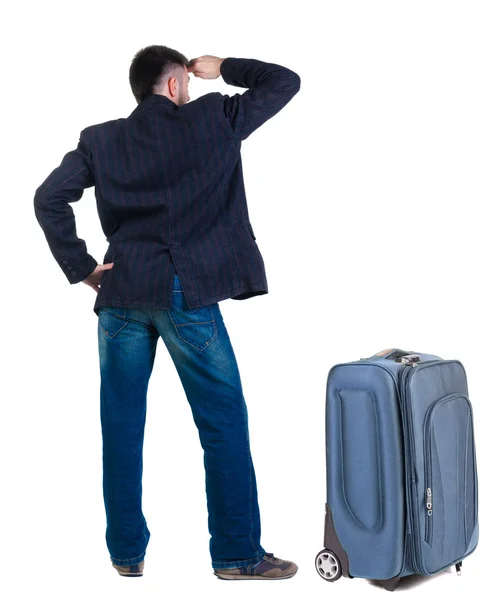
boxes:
[0,0,489,600]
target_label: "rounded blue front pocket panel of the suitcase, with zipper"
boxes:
[424,393,477,568]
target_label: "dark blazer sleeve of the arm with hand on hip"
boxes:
[34,131,98,283]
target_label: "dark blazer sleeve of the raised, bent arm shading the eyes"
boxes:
[219,58,301,140]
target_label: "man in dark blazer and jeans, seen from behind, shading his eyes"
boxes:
[34,46,300,579]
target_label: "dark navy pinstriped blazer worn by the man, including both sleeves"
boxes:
[34,58,300,315]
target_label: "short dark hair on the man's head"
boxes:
[129,46,189,104]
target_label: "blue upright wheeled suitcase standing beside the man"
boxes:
[316,348,479,591]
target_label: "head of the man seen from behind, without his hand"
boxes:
[129,46,190,106]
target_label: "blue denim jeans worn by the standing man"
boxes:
[98,275,265,568]
